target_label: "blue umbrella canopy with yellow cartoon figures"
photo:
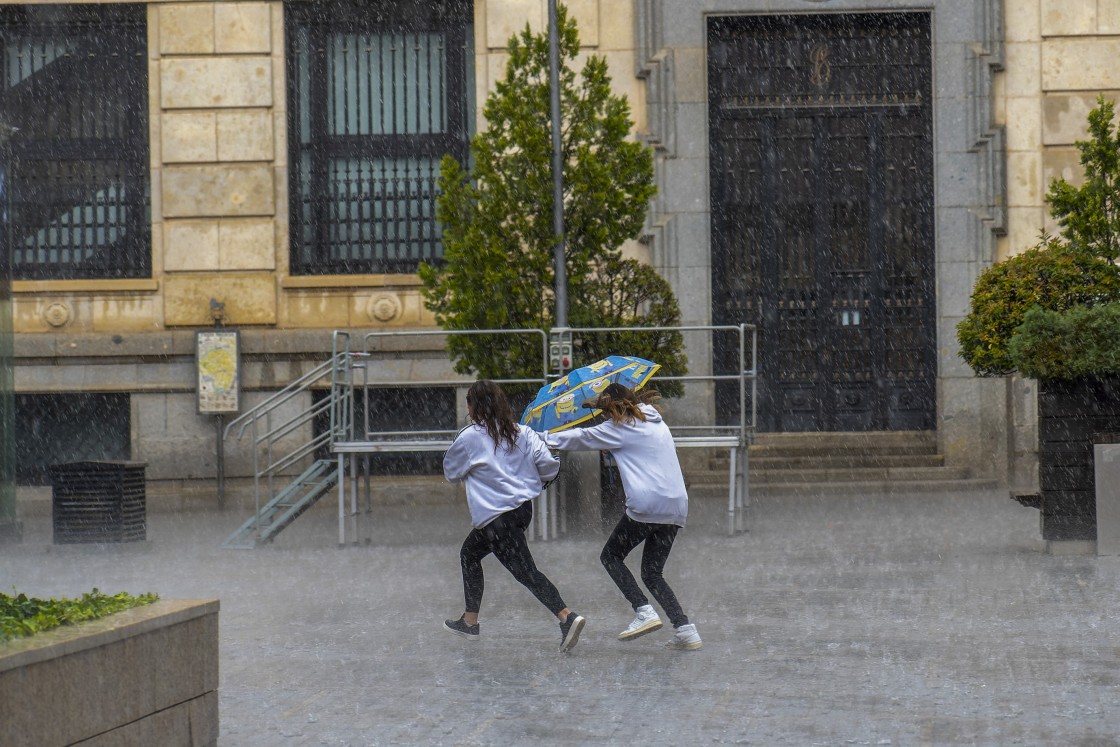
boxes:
[521,355,661,432]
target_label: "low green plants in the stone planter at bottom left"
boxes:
[0,588,159,642]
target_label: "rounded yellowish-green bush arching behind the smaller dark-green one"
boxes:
[956,237,1120,376]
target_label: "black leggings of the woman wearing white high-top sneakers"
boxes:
[599,514,689,627]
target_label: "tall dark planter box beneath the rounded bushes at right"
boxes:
[1038,376,1120,542]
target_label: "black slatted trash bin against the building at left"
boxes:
[49,461,148,544]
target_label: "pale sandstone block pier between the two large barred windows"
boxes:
[149,2,286,327]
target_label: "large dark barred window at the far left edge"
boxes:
[0,4,151,280]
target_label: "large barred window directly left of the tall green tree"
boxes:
[286,0,474,274]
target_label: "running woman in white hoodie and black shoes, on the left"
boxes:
[444,380,586,651]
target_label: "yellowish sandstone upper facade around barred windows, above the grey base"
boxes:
[8,0,645,335]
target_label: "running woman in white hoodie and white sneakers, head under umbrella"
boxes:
[545,383,703,650]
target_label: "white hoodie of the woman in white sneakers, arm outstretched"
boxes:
[545,404,689,526]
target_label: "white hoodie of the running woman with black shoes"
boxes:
[444,423,560,527]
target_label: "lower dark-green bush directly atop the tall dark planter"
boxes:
[1009,304,1120,380]
